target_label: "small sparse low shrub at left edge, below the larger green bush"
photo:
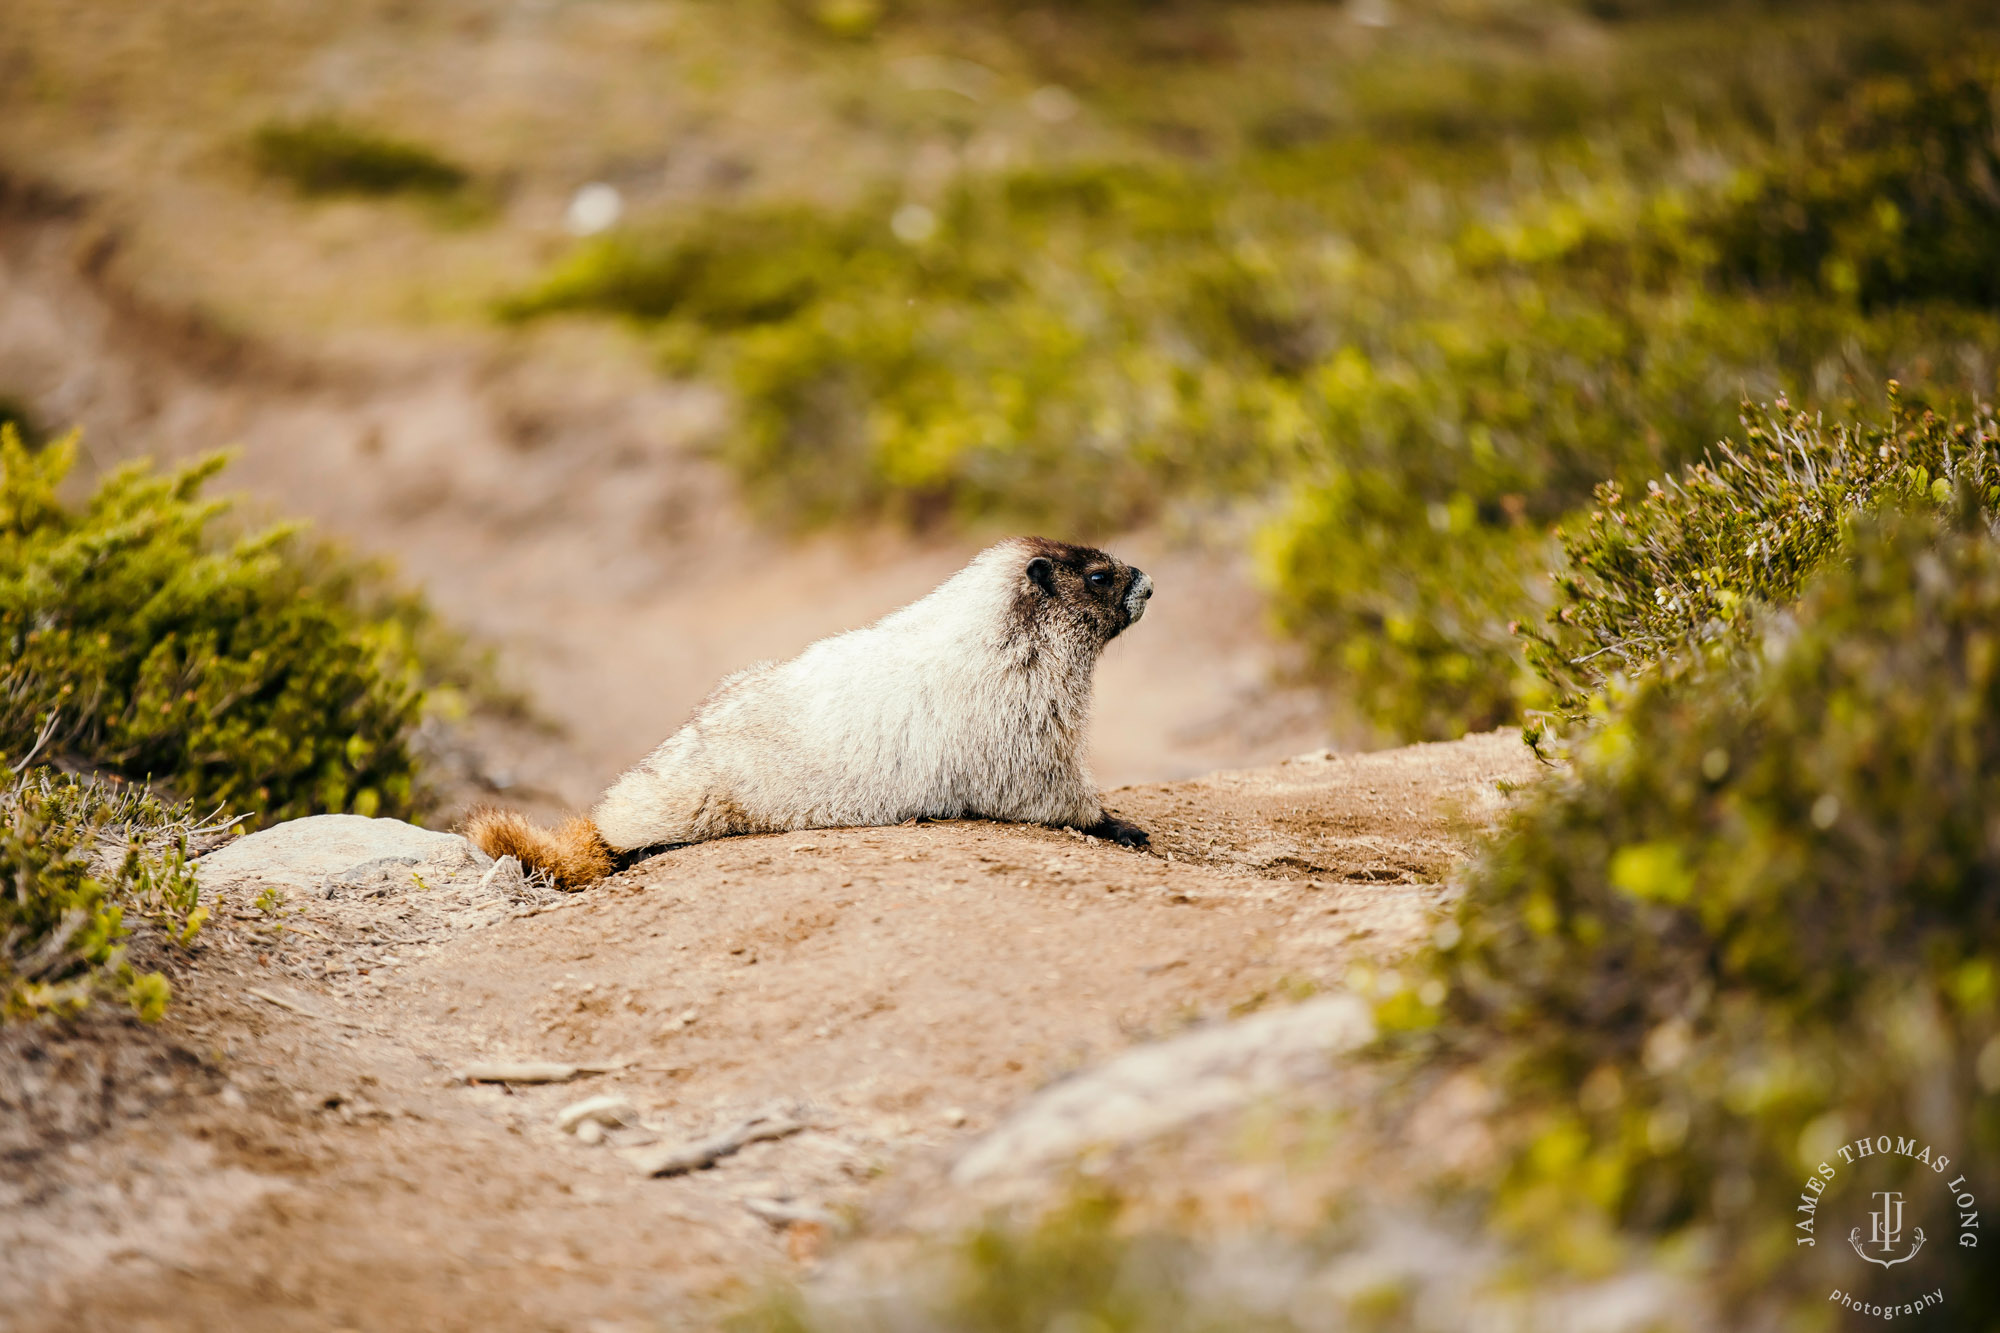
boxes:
[0,769,214,1021]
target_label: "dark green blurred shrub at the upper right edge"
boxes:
[1710,62,2000,306]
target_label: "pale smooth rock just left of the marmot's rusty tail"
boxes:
[194,815,492,889]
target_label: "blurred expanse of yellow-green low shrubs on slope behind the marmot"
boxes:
[504,4,2000,737]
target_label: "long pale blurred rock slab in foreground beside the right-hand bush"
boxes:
[952,995,1374,1185]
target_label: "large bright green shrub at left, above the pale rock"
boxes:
[0,428,422,819]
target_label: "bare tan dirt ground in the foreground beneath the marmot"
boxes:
[0,733,1532,1333]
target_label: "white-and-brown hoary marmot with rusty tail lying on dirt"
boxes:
[466,536,1152,889]
